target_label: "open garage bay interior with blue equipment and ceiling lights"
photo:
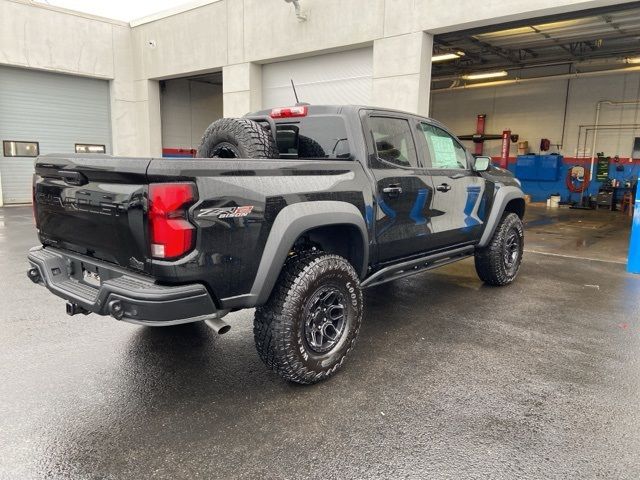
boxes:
[431,4,640,263]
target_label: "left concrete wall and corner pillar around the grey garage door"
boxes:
[0,0,160,155]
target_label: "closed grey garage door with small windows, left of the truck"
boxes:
[0,67,111,204]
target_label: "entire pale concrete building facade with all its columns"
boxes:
[0,0,629,159]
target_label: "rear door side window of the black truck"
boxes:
[369,117,418,168]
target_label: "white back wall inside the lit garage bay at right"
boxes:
[431,73,640,157]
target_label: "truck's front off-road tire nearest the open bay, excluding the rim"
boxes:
[475,212,524,286]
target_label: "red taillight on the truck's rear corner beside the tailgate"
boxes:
[149,183,196,259]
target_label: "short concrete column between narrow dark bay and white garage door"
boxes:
[222,63,262,117]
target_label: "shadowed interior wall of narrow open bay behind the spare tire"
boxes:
[160,79,222,149]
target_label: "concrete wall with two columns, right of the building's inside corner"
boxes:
[133,0,627,139]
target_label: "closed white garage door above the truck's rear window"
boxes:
[262,48,373,108]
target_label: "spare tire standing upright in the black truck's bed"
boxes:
[197,118,279,158]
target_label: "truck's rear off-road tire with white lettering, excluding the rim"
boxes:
[253,251,363,384]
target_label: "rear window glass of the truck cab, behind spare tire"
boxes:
[276,115,351,159]
